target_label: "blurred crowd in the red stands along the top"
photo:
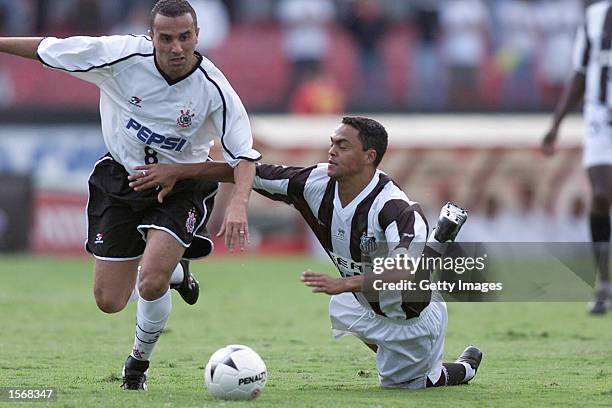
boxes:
[0,0,587,113]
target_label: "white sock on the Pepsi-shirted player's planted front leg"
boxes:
[131,290,172,360]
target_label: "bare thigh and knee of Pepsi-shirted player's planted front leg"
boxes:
[139,228,185,300]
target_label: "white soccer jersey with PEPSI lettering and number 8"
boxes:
[38,35,261,173]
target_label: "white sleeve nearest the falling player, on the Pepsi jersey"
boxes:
[206,63,261,167]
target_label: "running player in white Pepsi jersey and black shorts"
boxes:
[0,0,260,389]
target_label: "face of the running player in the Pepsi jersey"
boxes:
[152,13,199,79]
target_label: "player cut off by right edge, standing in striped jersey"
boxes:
[542,0,612,314]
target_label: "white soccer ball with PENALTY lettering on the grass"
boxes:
[204,344,268,400]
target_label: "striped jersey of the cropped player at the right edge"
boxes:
[573,0,612,125]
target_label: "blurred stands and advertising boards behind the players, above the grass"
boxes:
[0,0,588,254]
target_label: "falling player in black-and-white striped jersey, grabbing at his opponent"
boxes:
[130,117,482,389]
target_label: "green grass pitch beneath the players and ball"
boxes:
[0,256,612,407]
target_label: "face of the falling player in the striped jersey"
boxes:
[327,124,376,179]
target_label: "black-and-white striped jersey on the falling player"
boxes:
[253,163,428,319]
